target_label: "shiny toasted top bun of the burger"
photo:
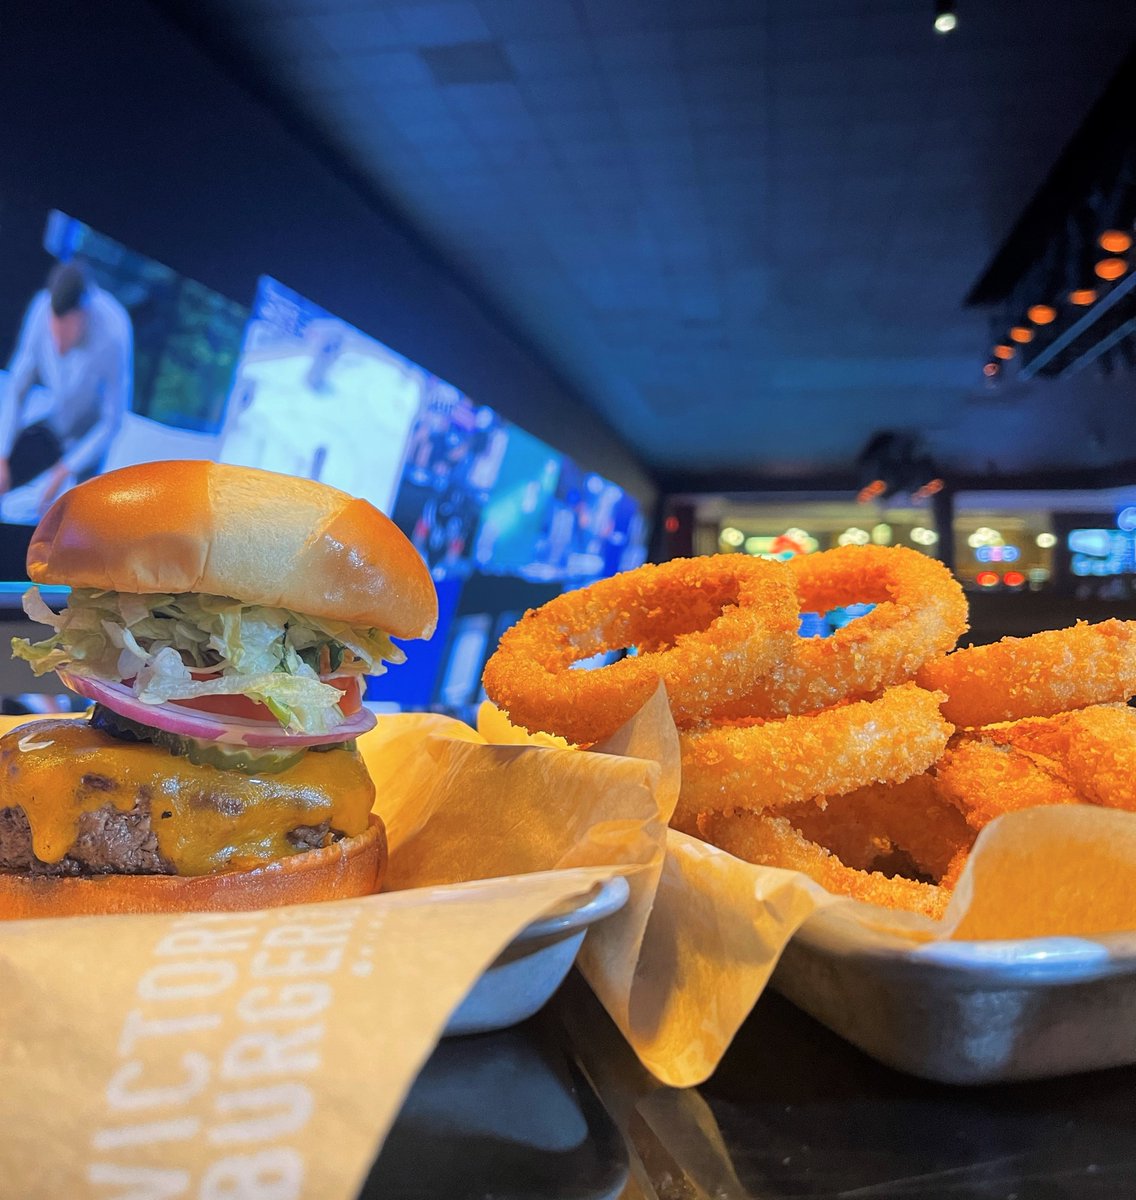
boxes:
[28,460,438,637]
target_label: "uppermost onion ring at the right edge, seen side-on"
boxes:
[916,620,1136,728]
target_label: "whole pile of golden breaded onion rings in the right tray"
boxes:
[485,546,1136,917]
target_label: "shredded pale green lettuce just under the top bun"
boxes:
[12,587,405,733]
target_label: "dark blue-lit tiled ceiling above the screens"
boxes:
[155,0,1136,487]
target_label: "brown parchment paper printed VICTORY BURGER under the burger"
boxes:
[0,695,678,1200]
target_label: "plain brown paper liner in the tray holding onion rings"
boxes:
[481,708,1136,1087]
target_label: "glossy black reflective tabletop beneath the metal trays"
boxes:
[362,976,1136,1200]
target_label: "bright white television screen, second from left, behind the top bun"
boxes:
[220,276,427,514]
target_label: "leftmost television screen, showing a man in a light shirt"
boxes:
[0,206,248,578]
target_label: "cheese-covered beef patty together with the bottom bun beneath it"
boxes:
[0,708,386,919]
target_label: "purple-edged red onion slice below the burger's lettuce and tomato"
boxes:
[58,671,375,748]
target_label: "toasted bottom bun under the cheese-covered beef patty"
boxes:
[0,816,386,920]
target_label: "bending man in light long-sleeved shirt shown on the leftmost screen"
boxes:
[0,262,134,511]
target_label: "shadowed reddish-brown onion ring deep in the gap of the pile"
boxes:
[777,772,975,883]
